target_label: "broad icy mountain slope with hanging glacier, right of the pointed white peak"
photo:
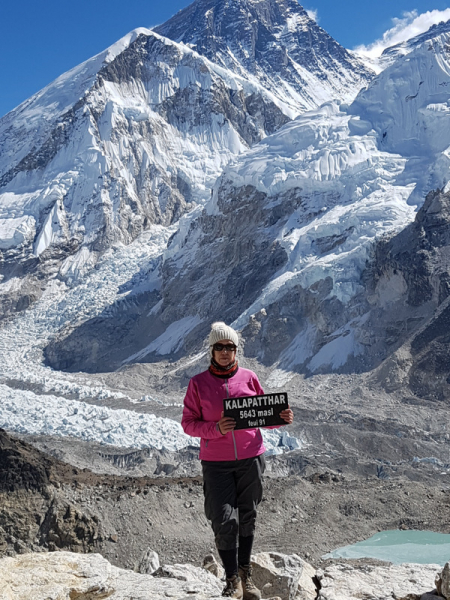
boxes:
[43,25,450,390]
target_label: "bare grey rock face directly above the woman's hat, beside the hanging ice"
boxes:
[158,181,287,344]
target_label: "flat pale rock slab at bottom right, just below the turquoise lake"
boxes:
[317,563,439,600]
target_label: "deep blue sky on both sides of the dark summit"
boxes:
[0,0,450,117]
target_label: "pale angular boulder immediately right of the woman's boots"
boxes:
[252,552,317,600]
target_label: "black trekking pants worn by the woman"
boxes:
[202,454,266,550]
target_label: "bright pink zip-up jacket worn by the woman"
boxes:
[181,367,266,460]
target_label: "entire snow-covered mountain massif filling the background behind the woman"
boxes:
[0,0,450,448]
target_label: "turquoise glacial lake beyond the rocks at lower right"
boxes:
[322,529,450,566]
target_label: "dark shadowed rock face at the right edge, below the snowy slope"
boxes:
[364,190,450,400]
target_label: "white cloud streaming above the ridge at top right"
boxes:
[355,8,450,58]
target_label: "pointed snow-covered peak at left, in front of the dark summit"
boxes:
[0,30,288,256]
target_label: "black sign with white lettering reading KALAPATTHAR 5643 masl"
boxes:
[223,392,289,429]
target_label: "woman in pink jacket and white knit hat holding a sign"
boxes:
[181,322,294,600]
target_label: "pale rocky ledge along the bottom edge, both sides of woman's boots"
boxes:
[0,552,449,600]
